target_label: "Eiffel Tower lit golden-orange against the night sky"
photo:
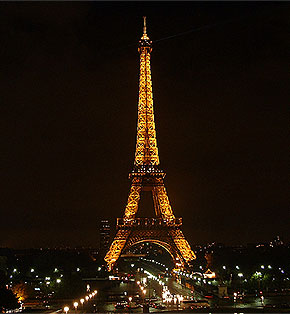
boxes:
[105,17,196,270]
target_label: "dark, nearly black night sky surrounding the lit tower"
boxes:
[0,2,290,248]
